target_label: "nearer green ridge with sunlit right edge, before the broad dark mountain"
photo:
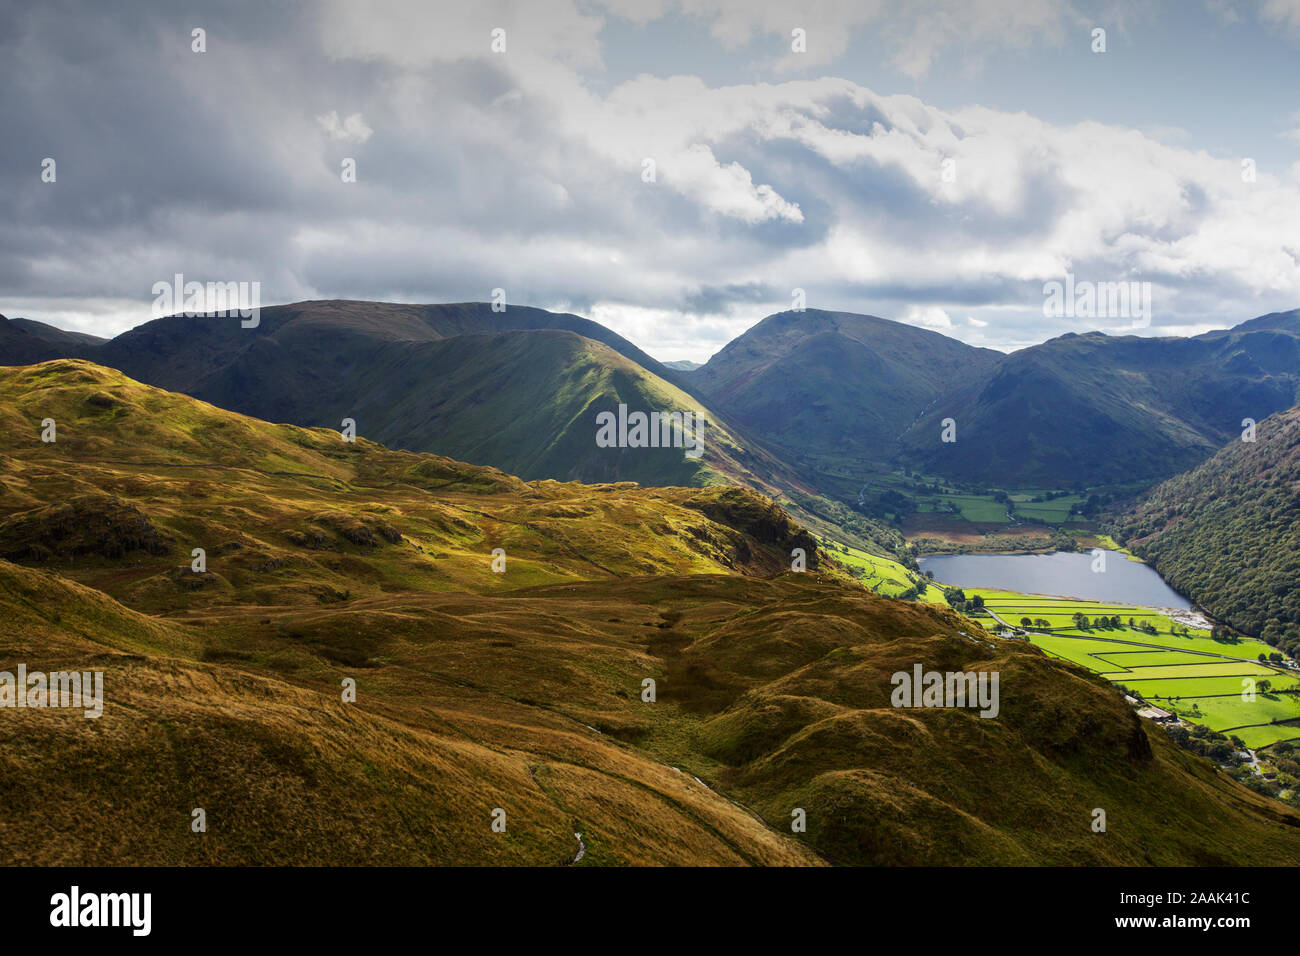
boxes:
[194,330,771,486]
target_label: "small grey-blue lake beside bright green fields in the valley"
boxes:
[917,551,1191,609]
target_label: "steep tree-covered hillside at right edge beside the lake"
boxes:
[1113,407,1300,656]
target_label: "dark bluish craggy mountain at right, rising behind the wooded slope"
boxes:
[904,311,1300,488]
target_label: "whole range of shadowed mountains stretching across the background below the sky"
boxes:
[0,300,1300,502]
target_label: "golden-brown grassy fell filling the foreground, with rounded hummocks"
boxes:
[0,360,1300,865]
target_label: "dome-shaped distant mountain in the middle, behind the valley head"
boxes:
[690,308,1004,462]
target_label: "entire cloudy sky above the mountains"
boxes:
[0,0,1300,362]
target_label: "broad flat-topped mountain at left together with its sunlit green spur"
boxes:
[3,302,898,553]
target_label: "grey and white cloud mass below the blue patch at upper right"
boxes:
[0,0,1300,359]
